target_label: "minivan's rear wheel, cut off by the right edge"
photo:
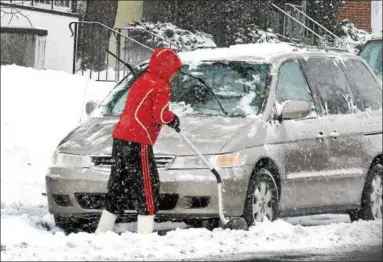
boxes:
[349,163,383,222]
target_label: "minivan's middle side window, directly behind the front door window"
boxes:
[302,57,354,115]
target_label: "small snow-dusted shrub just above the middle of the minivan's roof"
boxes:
[234,24,281,44]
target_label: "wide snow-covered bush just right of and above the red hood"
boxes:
[128,21,217,50]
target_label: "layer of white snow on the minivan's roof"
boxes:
[179,43,304,63]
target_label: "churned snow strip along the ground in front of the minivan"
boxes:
[1,215,382,261]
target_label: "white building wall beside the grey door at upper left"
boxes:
[1,6,79,73]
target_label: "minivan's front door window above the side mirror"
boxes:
[276,61,313,107]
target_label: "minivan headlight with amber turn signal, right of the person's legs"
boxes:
[169,153,240,169]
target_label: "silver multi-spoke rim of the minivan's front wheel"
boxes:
[253,182,273,222]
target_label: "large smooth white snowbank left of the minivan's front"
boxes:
[1,65,114,211]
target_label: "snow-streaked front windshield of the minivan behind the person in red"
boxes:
[92,62,270,117]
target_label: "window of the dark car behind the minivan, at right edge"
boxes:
[359,41,383,77]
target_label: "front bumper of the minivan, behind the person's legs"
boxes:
[46,166,252,220]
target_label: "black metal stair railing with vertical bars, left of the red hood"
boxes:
[69,21,153,82]
